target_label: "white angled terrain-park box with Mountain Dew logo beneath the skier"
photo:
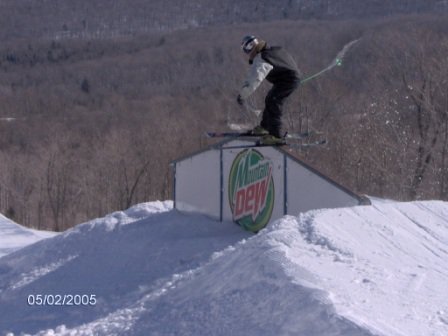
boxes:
[172,140,366,232]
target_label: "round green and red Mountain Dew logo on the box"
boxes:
[229,149,274,232]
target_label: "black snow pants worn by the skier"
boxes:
[260,81,300,138]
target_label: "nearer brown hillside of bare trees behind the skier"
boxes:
[0,8,448,230]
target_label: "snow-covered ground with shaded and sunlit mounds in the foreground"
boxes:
[0,199,448,336]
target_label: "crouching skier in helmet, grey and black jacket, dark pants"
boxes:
[237,35,300,145]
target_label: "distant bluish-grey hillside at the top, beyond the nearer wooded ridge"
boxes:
[0,0,448,41]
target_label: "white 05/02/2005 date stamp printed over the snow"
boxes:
[27,294,97,306]
